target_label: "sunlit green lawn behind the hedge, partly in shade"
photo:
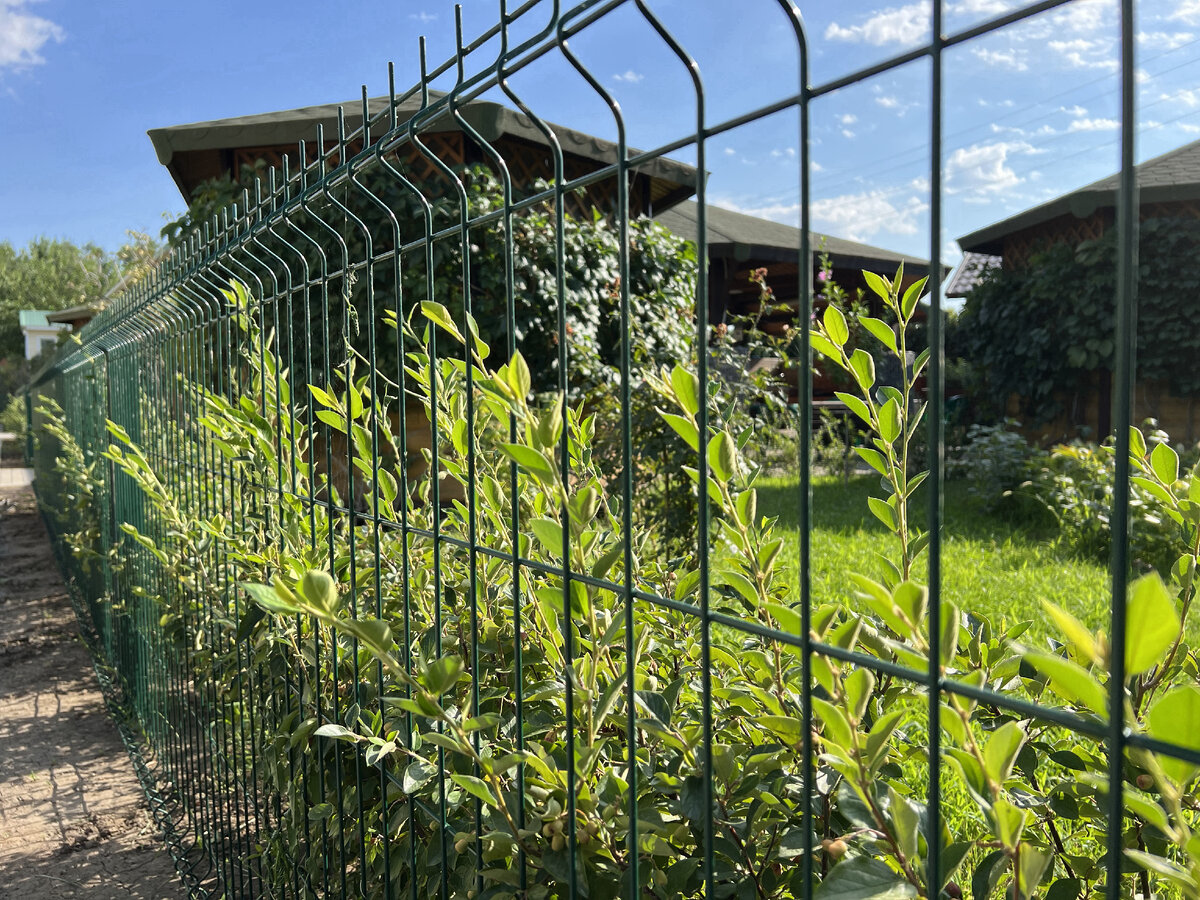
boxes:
[758,475,1109,640]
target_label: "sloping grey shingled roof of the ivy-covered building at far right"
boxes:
[959,140,1200,254]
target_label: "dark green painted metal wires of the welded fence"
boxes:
[21,0,1161,900]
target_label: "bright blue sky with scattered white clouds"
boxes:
[0,0,1200,271]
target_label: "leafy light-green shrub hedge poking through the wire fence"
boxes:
[44,274,1200,900]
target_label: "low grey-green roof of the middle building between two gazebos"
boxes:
[654,200,929,275]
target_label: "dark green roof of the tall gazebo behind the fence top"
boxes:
[146,91,696,206]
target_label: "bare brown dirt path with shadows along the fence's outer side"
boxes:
[0,487,184,900]
